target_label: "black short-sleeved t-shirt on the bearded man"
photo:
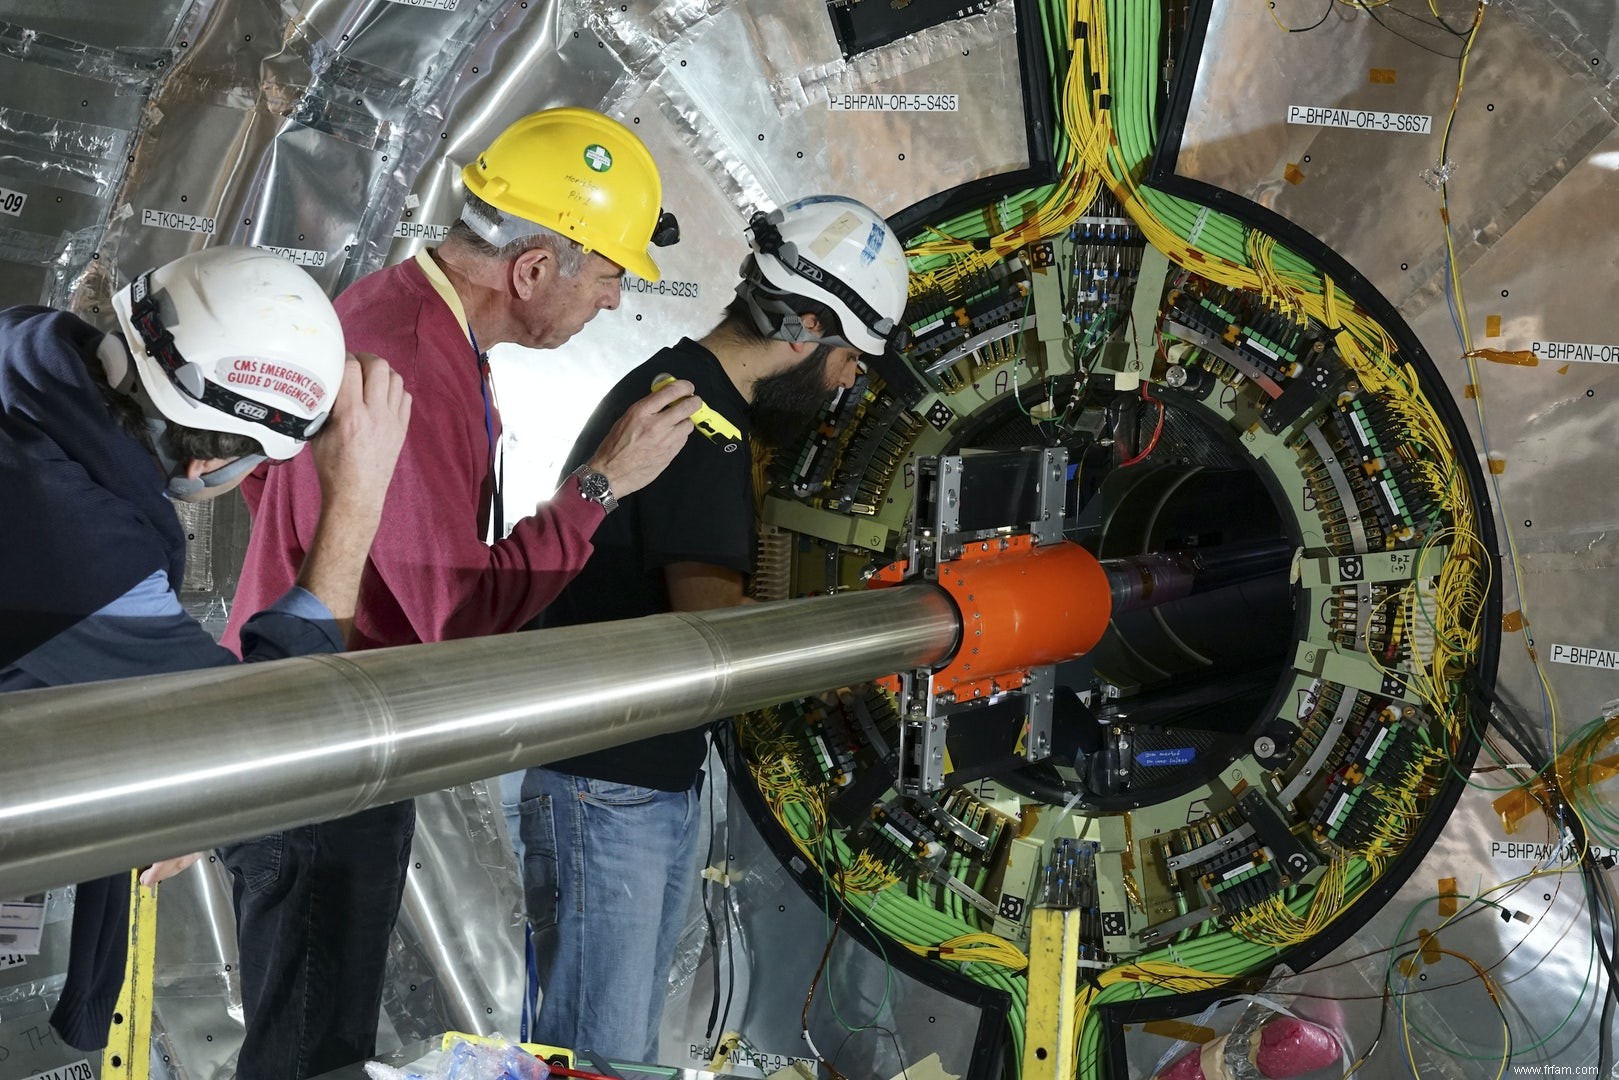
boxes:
[541,338,756,792]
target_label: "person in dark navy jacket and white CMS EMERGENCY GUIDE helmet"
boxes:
[0,248,410,1049]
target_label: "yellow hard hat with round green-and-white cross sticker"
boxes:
[461,108,675,282]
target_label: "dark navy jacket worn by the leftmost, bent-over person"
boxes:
[0,308,343,1051]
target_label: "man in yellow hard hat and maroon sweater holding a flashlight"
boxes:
[223,108,701,1080]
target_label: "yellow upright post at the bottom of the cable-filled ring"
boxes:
[1020,907,1080,1080]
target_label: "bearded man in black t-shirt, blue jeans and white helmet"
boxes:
[508,196,907,1062]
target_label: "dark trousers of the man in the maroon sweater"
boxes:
[219,800,416,1080]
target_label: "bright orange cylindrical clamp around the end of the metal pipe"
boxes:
[871,534,1112,691]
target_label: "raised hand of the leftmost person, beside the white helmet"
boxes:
[309,353,410,517]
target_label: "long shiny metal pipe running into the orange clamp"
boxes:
[0,586,960,899]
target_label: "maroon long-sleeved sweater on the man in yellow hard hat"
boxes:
[225,261,602,649]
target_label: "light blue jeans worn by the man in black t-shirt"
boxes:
[520,769,701,1062]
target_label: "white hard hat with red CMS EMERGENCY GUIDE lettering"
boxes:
[112,246,345,460]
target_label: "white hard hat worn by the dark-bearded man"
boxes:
[737,194,910,355]
